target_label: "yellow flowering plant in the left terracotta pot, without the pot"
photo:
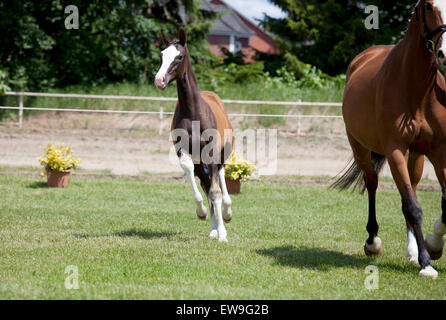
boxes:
[38,142,81,171]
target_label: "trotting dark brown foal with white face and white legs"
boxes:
[155,29,233,242]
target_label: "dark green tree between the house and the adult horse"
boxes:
[262,0,415,75]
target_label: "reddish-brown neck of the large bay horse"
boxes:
[396,15,437,102]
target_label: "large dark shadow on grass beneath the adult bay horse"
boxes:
[256,246,441,273]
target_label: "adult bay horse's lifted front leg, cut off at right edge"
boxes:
[425,152,446,260]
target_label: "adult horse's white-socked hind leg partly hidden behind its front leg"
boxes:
[406,153,424,264]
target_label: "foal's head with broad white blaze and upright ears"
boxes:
[155,29,188,90]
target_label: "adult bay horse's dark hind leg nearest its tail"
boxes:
[348,135,383,256]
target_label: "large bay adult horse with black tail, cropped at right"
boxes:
[335,0,446,279]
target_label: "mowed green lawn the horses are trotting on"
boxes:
[0,174,446,299]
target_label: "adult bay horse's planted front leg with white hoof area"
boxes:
[386,148,438,279]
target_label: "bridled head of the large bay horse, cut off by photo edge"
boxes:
[416,0,446,68]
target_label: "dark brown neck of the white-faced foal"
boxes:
[177,55,200,119]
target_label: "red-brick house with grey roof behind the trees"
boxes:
[200,0,279,63]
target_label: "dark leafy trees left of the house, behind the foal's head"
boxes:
[0,0,216,90]
